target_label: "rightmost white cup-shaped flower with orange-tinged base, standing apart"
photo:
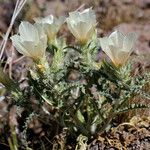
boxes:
[100,31,137,67]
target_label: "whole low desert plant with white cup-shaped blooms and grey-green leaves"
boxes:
[0,8,150,148]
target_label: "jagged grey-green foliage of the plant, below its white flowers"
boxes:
[1,28,150,149]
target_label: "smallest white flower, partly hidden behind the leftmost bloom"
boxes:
[34,15,65,42]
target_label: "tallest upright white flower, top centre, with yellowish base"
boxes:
[67,8,96,44]
